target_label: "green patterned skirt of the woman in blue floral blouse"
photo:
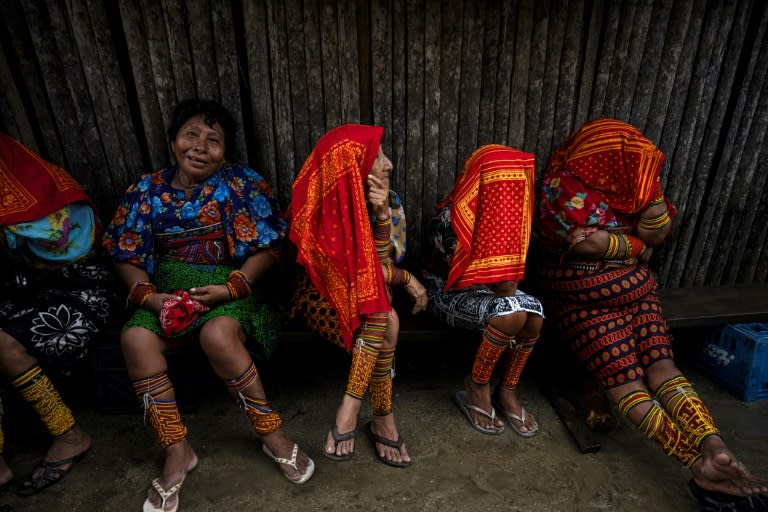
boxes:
[123,258,282,357]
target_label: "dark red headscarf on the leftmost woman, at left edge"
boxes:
[0,133,93,226]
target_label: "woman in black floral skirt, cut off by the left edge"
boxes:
[0,133,110,495]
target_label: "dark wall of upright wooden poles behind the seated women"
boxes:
[0,0,768,287]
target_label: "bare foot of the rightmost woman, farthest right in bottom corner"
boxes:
[691,436,768,496]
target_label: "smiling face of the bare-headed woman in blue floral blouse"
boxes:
[171,116,226,182]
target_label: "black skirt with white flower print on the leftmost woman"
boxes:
[0,259,114,374]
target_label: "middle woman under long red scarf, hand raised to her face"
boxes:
[290,125,427,467]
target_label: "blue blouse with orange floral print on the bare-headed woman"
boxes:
[102,164,287,275]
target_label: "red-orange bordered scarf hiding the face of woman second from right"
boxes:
[445,144,535,289]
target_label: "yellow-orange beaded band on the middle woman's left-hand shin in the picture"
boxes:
[345,313,387,400]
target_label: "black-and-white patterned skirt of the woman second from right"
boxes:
[423,272,544,331]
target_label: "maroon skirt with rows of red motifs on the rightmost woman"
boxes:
[539,265,674,388]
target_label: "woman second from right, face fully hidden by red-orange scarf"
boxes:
[424,145,543,437]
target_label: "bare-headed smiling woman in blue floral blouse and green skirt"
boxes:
[104,100,314,511]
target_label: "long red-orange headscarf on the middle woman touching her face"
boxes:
[289,124,391,349]
